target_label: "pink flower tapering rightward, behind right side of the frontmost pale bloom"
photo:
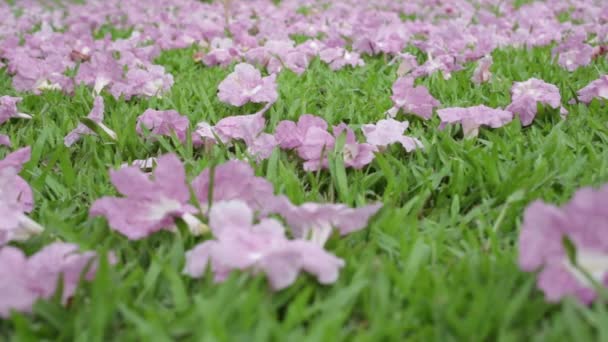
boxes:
[279,203,382,246]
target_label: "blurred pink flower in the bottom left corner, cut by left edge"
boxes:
[0,242,103,318]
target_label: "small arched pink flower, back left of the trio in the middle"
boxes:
[274,114,327,149]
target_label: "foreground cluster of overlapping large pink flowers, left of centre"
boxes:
[90,155,382,290]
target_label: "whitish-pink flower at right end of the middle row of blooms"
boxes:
[361,119,423,152]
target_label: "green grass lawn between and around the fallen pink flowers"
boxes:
[0,44,608,341]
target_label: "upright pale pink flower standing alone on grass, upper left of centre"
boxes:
[218,63,278,106]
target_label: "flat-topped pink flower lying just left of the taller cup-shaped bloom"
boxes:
[437,105,513,137]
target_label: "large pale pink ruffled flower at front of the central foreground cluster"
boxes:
[184,201,344,290]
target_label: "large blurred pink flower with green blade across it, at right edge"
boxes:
[519,185,608,303]
